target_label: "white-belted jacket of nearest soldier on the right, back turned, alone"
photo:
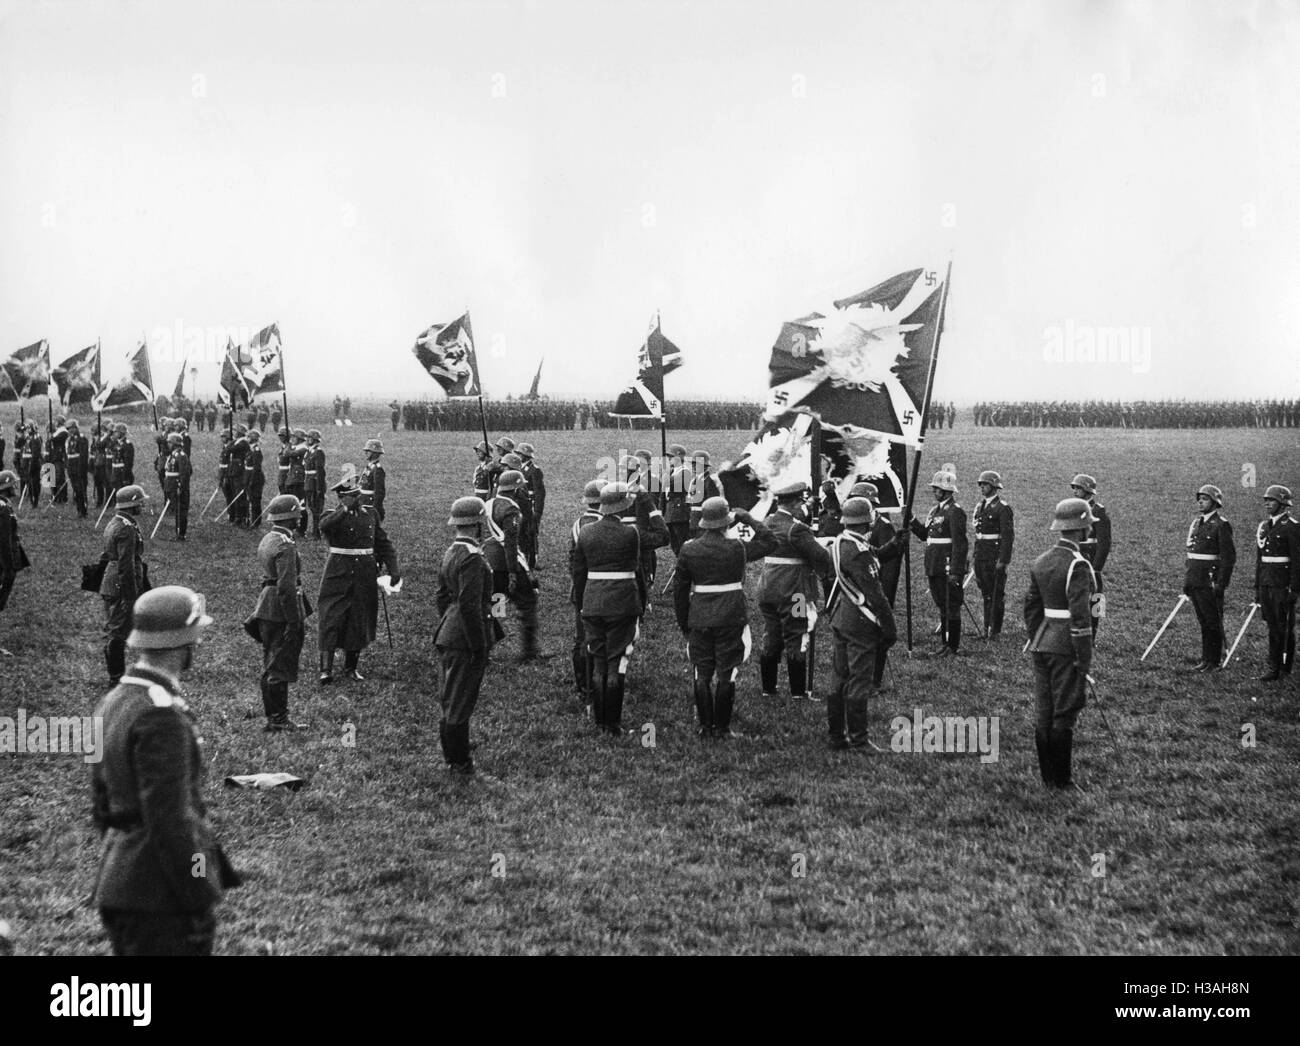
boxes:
[1024,538,1097,669]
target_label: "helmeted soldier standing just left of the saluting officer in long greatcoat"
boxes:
[252,494,311,733]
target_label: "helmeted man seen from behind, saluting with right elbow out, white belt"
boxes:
[673,498,776,738]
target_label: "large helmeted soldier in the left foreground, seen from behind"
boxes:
[91,585,241,955]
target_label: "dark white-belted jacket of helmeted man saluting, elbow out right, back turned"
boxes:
[673,520,777,631]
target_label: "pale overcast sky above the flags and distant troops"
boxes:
[0,0,1300,403]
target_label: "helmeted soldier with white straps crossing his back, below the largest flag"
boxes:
[826,495,898,751]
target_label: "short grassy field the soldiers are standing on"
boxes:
[0,412,1300,954]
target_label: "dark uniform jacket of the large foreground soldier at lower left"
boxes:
[91,665,241,912]
